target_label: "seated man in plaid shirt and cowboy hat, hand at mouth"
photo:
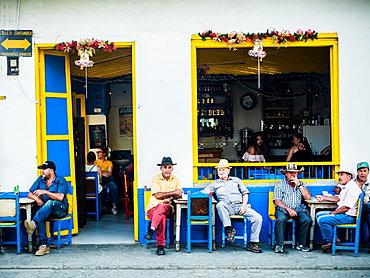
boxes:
[274,163,312,253]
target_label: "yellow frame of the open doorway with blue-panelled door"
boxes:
[34,42,139,241]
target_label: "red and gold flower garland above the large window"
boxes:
[198,28,318,50]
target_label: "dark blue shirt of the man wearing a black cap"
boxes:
[30,175,68,205]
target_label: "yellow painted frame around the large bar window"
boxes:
[191,33,340,183]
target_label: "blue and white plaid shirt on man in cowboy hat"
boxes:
[274,178,307,211]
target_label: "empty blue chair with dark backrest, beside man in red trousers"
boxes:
[186,192,213,253]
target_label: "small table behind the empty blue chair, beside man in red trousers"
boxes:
[173,195,217,252]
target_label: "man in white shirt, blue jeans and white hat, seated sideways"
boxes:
[316,169,362,252]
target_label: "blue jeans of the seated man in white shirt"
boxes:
[316,211,356,242]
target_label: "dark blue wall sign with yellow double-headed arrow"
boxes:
[0,30,33,57]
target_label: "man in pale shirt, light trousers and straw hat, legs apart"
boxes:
[203,159,262,253]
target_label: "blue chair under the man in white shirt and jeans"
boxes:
[332,193,364,257]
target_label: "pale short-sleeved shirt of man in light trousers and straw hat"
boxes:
[206,177,249,204]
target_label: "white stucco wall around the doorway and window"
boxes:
[0,0,370,191]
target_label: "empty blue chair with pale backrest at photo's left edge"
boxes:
[0,192,22,254]
